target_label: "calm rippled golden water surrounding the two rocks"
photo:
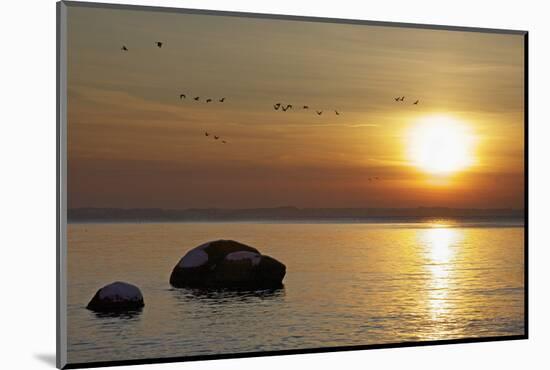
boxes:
[68,223,524,362]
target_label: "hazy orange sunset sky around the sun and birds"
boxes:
[68,6,524,208]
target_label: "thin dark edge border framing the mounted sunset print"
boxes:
[56,1,529,369]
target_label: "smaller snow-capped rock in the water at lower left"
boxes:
[86,281,144,312]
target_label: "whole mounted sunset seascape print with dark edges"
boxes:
[57,2,527,368]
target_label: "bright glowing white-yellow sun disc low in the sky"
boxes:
[407,115,475,175]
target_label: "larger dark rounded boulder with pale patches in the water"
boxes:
[170,240,286,289]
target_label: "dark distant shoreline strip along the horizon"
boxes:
[67,207,525,224]
